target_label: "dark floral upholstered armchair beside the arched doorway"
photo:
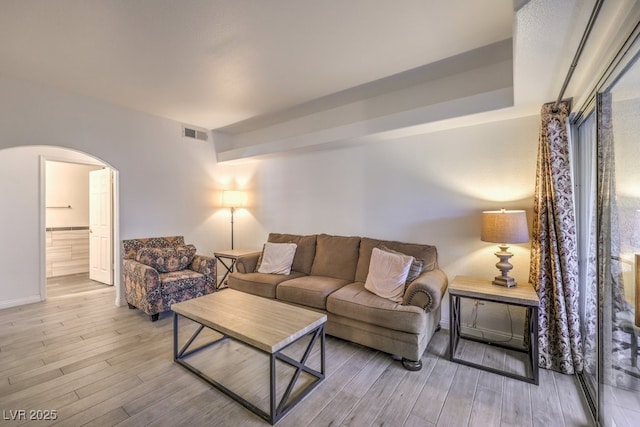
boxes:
[122,236,216,322]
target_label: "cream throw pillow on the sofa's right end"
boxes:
[364,248,414,303]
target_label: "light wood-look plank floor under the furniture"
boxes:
[0,277,593,427]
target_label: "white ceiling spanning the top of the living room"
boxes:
[0,0,634,150]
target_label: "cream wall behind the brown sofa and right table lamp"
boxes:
[228,116,539,335]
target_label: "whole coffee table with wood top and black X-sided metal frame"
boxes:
[171,289,327,424]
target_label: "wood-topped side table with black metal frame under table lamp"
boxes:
[447,276,540,385]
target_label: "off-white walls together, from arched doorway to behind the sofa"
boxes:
[0,72,538,338]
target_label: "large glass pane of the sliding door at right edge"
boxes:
[597,49,640,426]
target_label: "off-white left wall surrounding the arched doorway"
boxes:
[0,77,228,308]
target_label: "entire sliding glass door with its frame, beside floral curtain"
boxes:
[574,29,640,427]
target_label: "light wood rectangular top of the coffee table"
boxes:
[171,289,327,353]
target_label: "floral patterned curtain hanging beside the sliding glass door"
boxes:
[529,102,583,374]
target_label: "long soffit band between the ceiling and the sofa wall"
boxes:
[213,39,513,161]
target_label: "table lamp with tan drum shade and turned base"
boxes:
[480,209,529,287]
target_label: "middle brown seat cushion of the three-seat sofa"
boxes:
[276,276,349,310]
